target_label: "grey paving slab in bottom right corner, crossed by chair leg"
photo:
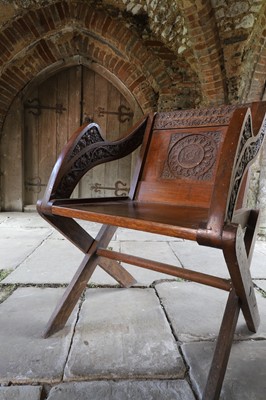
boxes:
[182,340,266,400]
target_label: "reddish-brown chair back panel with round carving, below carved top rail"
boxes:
[136,126,226,208]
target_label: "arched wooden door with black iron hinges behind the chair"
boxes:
[24,66,141,205]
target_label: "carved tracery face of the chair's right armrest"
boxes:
[227,117,266,221]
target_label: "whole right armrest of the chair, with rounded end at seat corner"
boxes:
[197,102,266,247]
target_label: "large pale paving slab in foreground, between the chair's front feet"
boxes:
[64,288,185,380]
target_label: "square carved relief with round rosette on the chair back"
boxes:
[161,131,220,180]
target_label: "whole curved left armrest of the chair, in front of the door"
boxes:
[37,116,148,213]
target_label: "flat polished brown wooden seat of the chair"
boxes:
[52,198,208,240]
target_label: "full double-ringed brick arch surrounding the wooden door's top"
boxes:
[0,0,197,131]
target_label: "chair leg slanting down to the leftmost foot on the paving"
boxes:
[43,225,117,337]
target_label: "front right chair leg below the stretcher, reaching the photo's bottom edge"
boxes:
[202,289,240,400]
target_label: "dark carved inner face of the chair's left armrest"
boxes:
[51,124,145,199]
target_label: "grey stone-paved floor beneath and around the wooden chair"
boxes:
[0,213,266,400]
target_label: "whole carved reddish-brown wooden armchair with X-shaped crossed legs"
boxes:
[37,102,266,400]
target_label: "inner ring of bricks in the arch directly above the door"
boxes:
[0,31,157,130]
